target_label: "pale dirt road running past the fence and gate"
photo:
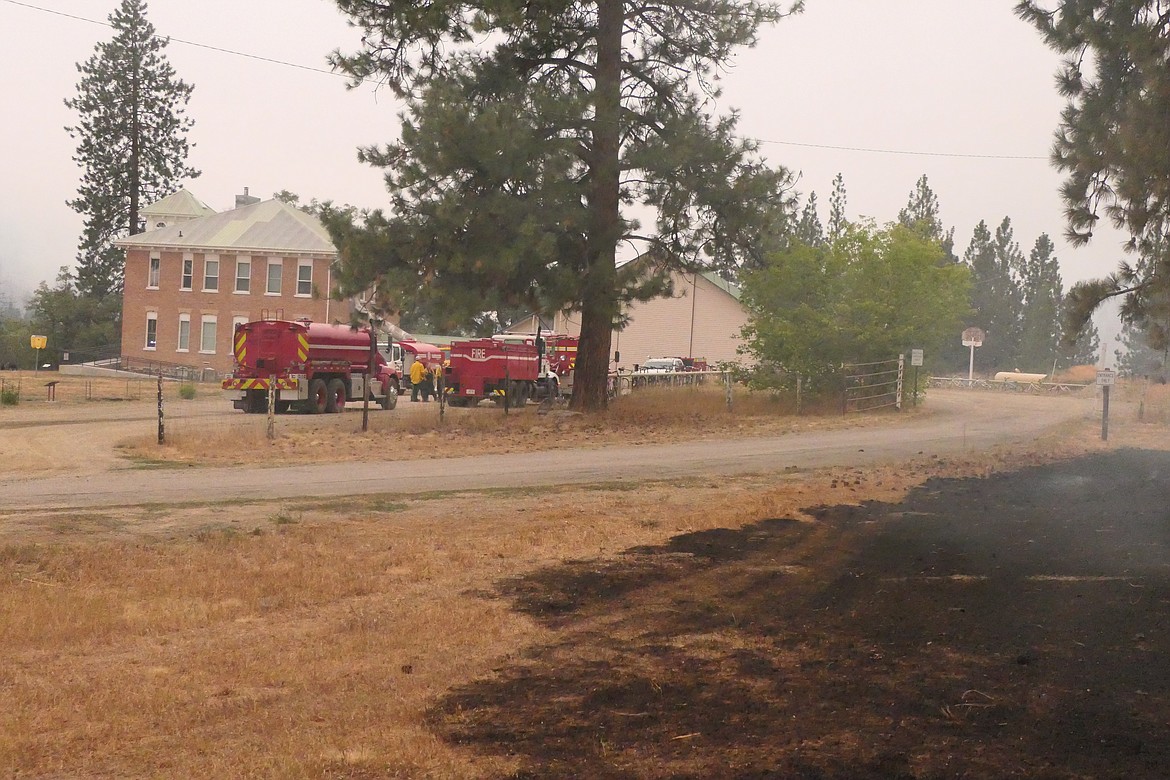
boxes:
[0,391,1092,510]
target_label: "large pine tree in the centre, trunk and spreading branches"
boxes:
[330,0,799,409]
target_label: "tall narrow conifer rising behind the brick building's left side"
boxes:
[66,0,199,297]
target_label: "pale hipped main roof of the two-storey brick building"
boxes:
[113,200,337,256]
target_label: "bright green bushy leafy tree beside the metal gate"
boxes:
[742,225,970,391]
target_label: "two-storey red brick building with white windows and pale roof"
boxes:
[115,191,350,374]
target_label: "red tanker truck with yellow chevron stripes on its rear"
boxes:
[222,319,441,414]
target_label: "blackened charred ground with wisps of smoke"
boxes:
[432,449,1170,778]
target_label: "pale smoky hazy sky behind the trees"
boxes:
[0,0,1122,334]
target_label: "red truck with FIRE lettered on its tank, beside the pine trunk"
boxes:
[443,336,577,407]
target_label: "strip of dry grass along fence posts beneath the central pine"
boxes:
[123,385,873,465]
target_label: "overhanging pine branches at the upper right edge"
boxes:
[1016,0,1170,337]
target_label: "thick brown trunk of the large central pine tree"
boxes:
[572,0,625,412]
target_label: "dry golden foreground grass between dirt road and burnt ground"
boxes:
[0,388,1166,778]
